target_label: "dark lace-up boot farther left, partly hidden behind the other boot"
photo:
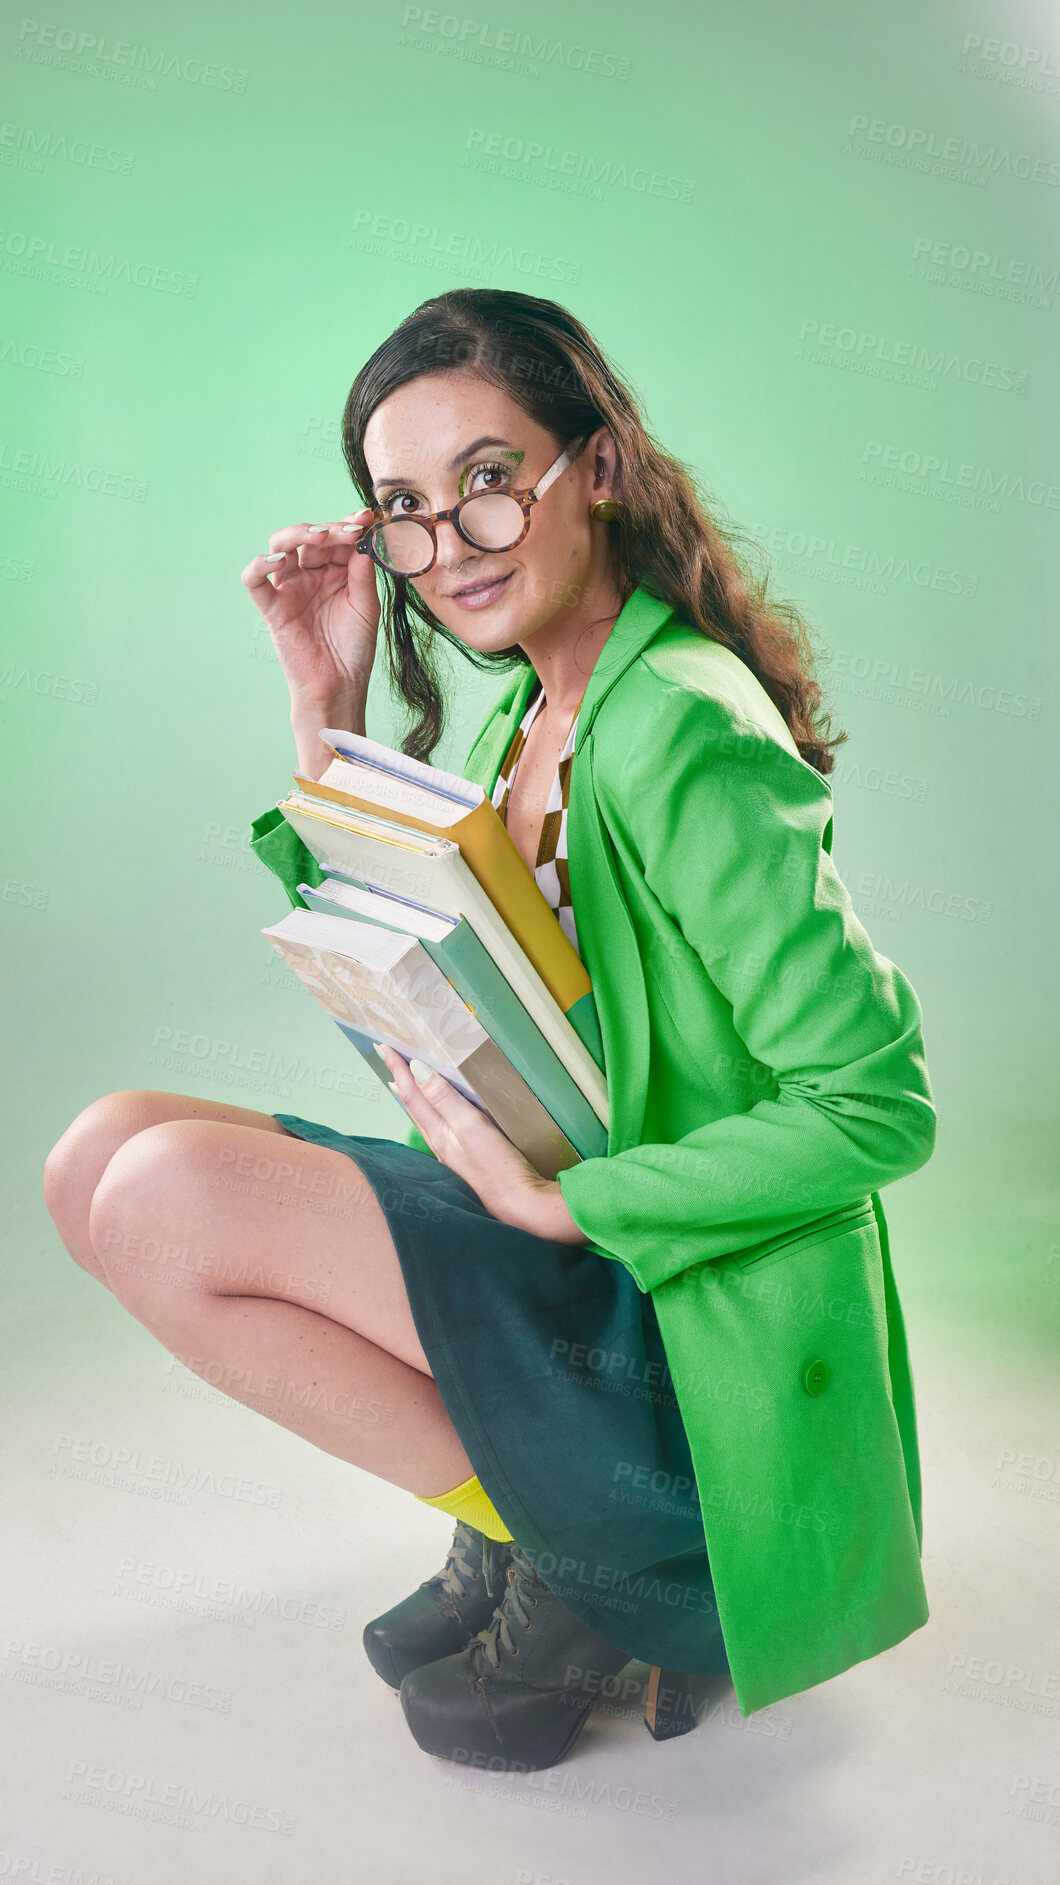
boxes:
[362,1519,511,1689]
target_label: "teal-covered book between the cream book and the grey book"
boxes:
[298,871,607,1159]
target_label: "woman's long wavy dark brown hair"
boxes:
[341,288,847,773]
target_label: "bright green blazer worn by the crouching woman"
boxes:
[251,588,936,1715]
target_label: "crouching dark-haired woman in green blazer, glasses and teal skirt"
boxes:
[45,290,934,1768]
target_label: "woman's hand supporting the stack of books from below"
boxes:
[377,1042,588,1244]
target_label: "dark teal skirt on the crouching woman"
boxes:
[273,1112,728,1676]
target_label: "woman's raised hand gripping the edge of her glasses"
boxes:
[241,509,379,779]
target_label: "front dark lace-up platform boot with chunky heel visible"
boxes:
[402,1546,696,1772]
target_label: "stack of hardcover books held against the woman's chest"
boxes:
[262,728,607,1178]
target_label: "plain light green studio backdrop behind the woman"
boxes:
[0,0,1060,1876]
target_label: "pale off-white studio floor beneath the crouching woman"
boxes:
[0,1212,1060,1885]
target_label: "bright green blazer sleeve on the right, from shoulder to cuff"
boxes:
[558,688,936,1291]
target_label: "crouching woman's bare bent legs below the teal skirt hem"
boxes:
[45,1093,473,1497]
